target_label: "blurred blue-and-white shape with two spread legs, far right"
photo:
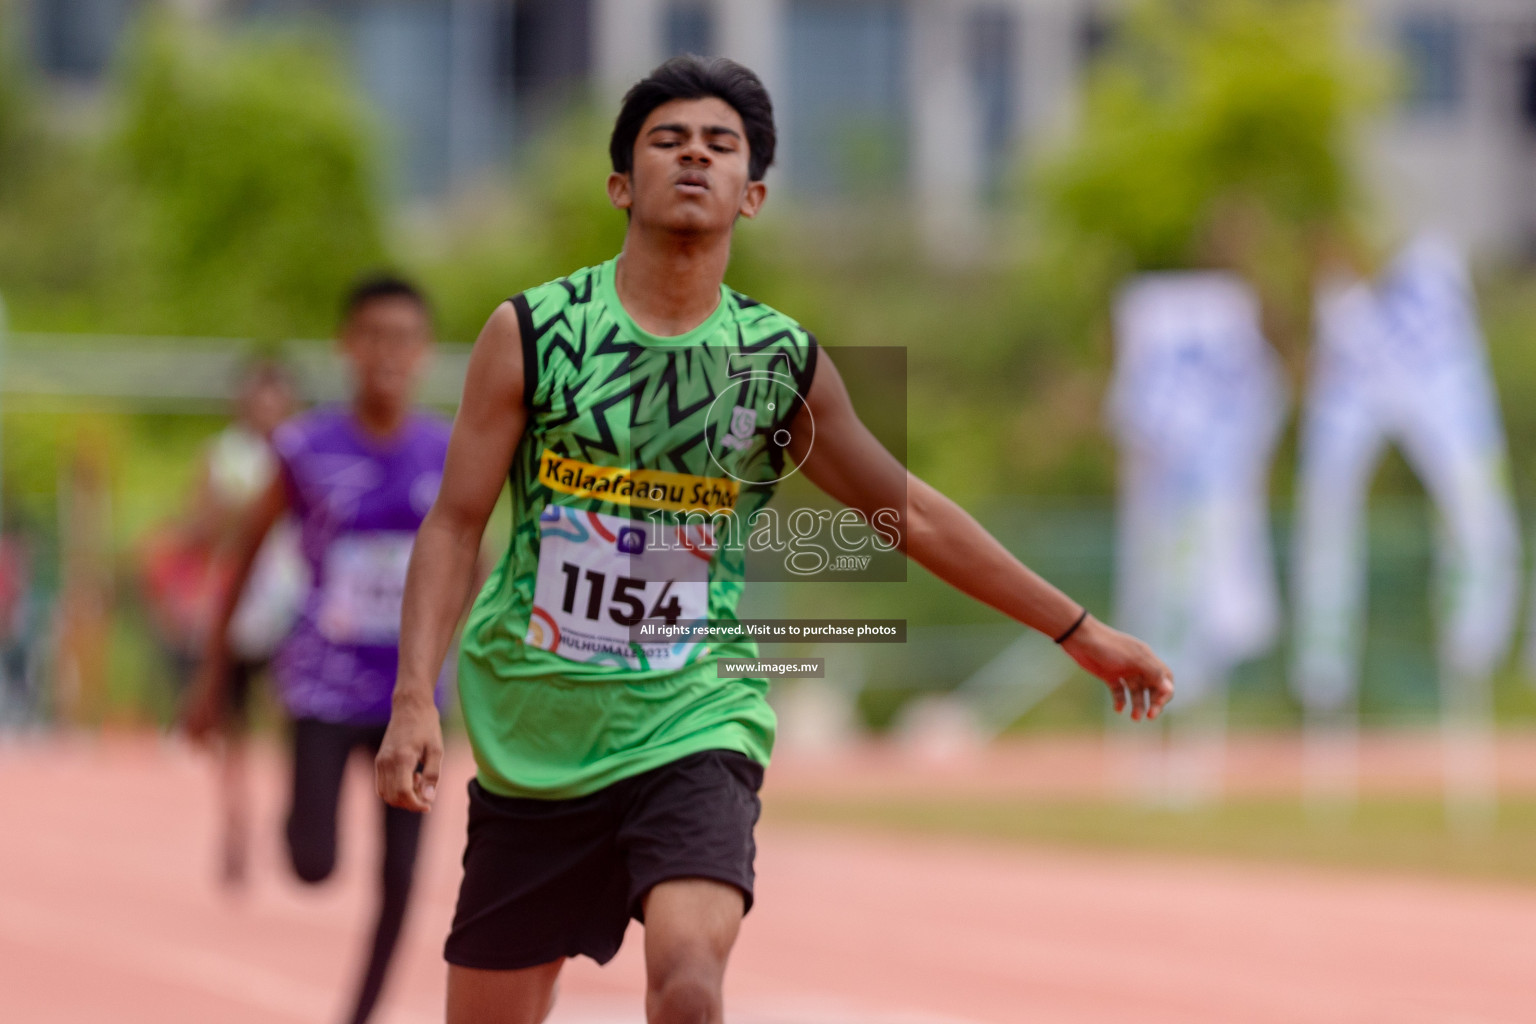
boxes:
[1292,238,1521,712]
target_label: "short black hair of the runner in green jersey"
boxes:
[608,55,777,181]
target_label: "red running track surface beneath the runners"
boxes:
[0,737,1536,1024]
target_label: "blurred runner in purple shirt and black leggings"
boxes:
[186,276,449,1024]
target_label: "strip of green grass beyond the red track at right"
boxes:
[763,797,1536,884]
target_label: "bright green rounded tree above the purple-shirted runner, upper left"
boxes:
[114,11,384,338]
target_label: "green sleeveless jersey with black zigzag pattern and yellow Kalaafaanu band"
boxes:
[459,261,816,798]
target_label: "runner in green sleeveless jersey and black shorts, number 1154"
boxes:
[378,57,1174,1024]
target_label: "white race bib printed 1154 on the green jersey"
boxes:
[524,505,716,669]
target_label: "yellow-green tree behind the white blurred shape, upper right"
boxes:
[1020,0,1385,405]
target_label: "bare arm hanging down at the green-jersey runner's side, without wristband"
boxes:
[375,302,527,811]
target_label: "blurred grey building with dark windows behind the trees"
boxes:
[25,0,1536,253]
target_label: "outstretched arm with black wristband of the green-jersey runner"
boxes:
[790,350,1174,718]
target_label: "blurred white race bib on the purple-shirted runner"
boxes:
[315,531,416,645]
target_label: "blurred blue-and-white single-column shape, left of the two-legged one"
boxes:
[1109,272,1286,703]
